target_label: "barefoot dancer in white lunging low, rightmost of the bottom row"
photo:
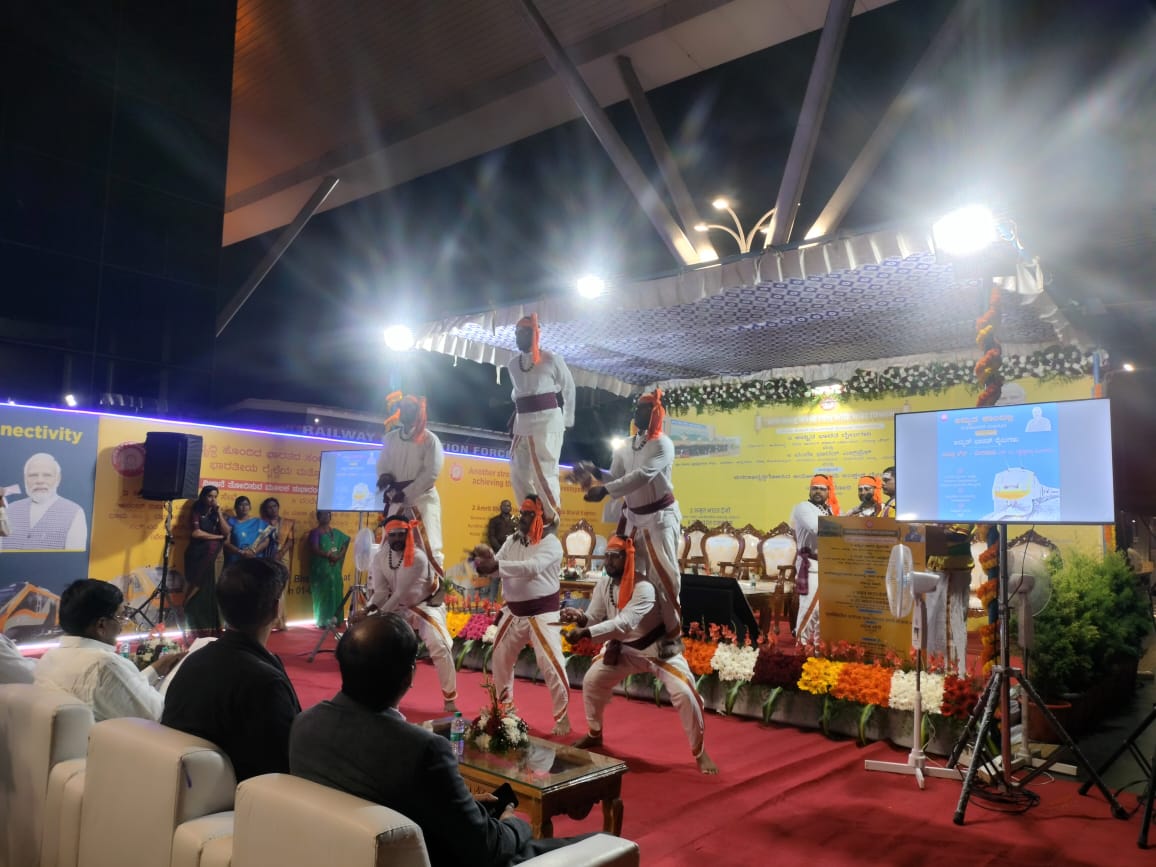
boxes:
[560,536,719,773]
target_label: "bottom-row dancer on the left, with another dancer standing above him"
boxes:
[350,514,458,713]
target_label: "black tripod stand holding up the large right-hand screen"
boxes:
[948,524,1128,825]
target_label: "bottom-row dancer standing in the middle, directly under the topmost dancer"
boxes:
[474,495,570,734]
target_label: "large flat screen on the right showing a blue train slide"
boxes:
[895,400,1116,524]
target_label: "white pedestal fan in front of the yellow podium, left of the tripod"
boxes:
[864,544,963,788]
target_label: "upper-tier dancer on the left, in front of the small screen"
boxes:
[377,393,445,576]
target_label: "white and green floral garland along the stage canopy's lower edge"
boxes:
[662,344,1092,415]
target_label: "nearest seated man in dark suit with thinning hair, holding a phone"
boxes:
[289,613,591,867]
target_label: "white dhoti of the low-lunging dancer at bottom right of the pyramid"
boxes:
[581,645,705,758]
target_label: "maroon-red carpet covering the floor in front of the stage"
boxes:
[271,629,1156,867]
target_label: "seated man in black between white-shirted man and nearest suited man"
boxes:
[161,557,301,783]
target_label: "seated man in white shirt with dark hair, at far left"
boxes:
[36,578,185,723]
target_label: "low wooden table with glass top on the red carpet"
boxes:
[459,738,627,837]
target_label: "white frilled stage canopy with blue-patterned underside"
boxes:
[417,230,1075,395]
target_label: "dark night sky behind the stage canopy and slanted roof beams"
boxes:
[215,0,1156,462]
